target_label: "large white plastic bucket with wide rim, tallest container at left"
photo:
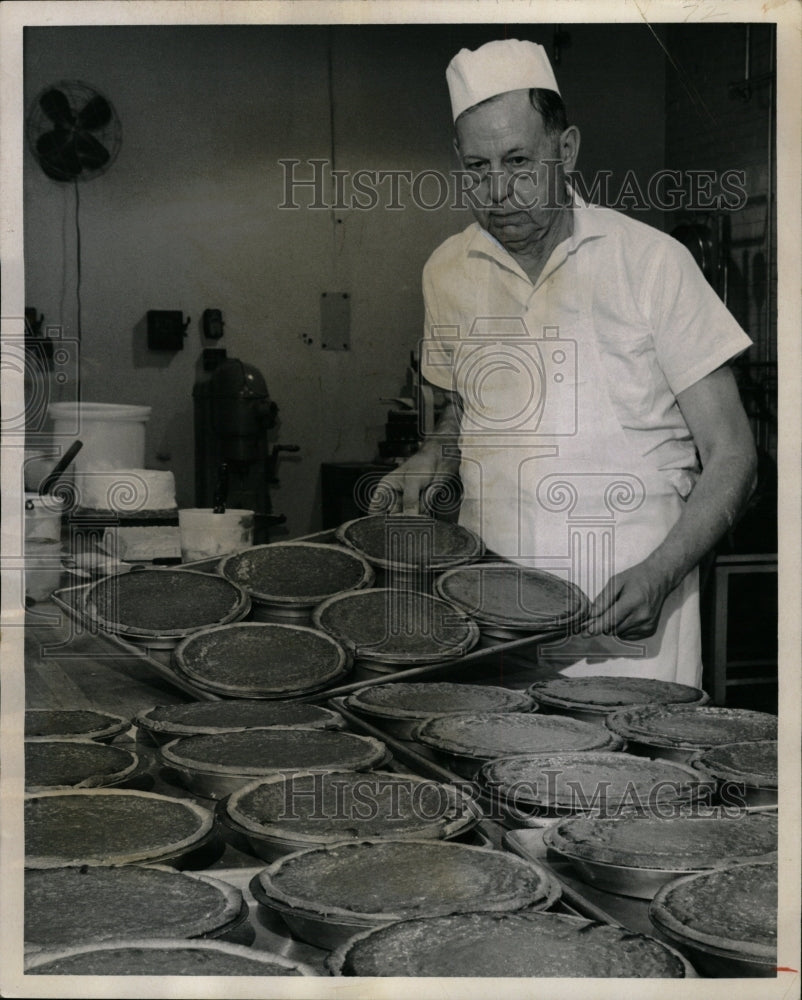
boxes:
[48,403,151,474]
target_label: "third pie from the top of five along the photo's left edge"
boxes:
[25,788,214,868]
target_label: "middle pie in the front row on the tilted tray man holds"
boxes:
[312,588,479,669]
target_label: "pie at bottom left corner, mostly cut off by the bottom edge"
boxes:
[25,938,319,976]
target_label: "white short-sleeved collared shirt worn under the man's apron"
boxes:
[421,195,751,495]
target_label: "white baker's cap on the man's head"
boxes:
[446,38,560,121]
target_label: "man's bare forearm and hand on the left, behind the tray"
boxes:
[370,392,460,514]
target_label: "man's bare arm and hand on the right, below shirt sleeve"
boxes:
[587,366,757,639]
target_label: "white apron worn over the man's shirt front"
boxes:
[455,243,702,687]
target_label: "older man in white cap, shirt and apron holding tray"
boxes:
[372,40,756,686]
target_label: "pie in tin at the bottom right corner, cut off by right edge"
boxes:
[649,862,777,978]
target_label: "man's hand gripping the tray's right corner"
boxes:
[585,559,670,639]
